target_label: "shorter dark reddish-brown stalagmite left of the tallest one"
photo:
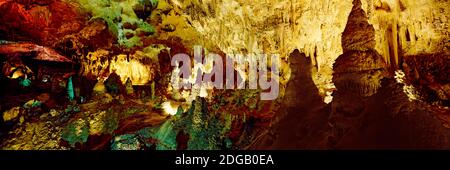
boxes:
[251,50,330,149]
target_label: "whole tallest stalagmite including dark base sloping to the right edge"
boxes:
[328,0,450,149]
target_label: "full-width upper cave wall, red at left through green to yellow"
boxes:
[0,0,450,101]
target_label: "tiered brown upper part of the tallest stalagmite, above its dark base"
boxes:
[333,0,386,97]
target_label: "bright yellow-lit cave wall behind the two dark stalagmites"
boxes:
[178,0,450,99]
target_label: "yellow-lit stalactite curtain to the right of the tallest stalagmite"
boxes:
[366,0,449,69]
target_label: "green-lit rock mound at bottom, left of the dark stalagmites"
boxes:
[111,97,233,150]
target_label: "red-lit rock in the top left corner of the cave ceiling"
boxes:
[0,0,85,45]
